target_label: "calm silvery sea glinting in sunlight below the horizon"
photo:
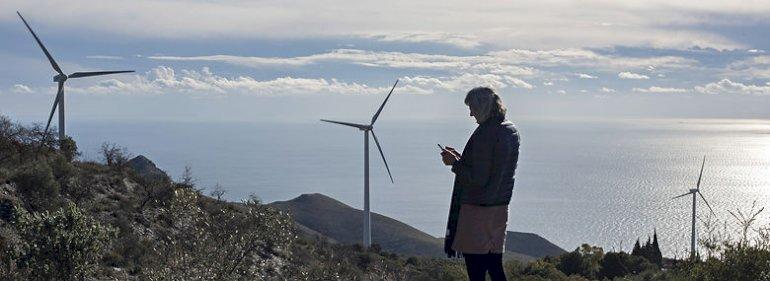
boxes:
[69,116,770,256]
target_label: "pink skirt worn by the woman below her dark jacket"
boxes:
[452,204,508,254]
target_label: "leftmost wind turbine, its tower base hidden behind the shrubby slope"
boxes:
[16,11,134,140]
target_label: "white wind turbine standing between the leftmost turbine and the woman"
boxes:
[321,80,398,249]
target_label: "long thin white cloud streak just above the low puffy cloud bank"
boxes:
[148,49,698,78]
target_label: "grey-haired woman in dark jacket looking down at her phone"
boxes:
[441,87,519,281]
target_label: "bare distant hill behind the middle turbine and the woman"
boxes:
[269,193,565,261]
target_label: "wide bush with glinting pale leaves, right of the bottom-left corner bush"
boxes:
[143,188,295,280]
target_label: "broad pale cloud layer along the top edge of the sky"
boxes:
[0,0,752,49]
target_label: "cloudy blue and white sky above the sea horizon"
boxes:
[0,0,770,122]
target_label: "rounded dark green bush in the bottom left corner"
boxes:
[8,204,113,280]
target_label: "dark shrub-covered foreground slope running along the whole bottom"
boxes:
[0,116,770,280]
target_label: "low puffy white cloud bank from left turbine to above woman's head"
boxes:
[57,66,534,96]
